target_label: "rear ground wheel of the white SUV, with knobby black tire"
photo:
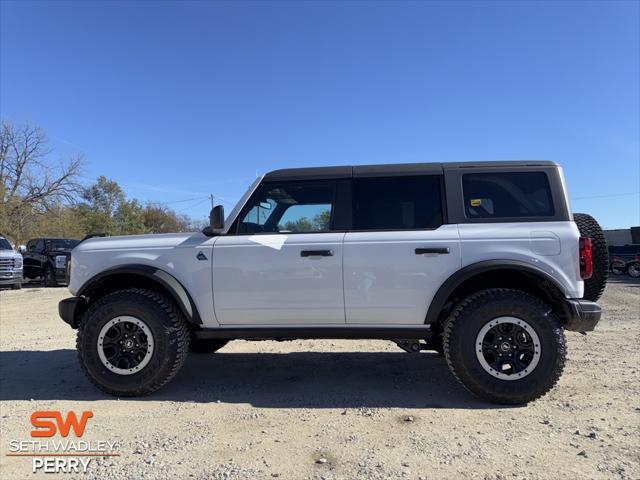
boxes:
[444,288,566,404]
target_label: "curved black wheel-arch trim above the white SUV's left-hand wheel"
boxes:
[77,264,202,325]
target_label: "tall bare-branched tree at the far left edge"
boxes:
[0,120,83,241]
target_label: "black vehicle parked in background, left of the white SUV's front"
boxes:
[22,238,80,287]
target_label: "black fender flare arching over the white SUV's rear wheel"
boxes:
[425,260,565,328]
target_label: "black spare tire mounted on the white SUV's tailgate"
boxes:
[573,213,609,302]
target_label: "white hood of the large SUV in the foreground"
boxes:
[73,232,206,252]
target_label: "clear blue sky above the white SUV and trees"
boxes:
[0,0,640,228]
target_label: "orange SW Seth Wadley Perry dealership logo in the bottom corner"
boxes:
[7,410,120,473]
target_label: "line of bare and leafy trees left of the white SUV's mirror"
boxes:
[0,120,202,244]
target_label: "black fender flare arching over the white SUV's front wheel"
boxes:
[76,264,202,325]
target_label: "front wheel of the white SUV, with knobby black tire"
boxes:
[77,288,189,397]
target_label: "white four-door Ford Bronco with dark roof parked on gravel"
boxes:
[59,161,608,404]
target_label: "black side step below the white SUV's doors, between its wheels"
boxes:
[194,325,433,340]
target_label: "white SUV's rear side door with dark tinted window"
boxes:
[344,173,460,325]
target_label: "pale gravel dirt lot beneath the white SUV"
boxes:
[0,278,640,479]
